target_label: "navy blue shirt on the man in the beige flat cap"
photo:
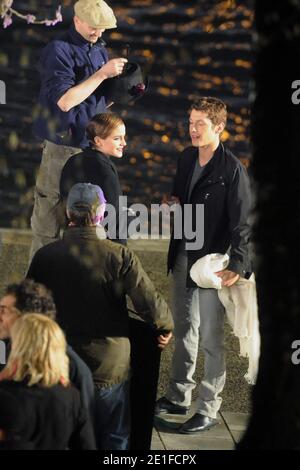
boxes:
[33,26,108,148]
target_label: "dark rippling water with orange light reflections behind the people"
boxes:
[0,0,253,228]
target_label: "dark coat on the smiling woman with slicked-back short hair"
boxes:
[60,148,127,244]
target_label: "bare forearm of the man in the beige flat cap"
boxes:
[57,70,107,112]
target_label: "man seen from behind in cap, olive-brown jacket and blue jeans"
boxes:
[28,183,173,450]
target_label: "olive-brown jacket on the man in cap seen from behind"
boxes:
[27,227,173,387]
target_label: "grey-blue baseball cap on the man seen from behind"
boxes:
[67,183,106,224]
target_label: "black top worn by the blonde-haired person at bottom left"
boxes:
[0,380,96,450]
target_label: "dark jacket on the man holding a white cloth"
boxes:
[168,144,252,287]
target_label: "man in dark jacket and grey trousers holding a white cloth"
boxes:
[156,97,251,433]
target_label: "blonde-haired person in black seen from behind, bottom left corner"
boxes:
[0,314,95,450]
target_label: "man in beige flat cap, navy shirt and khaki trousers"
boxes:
[30,0,127,258]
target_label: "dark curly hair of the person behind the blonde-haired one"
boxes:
[5,279,56,320]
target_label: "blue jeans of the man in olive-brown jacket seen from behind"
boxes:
[95,381,130,450]
